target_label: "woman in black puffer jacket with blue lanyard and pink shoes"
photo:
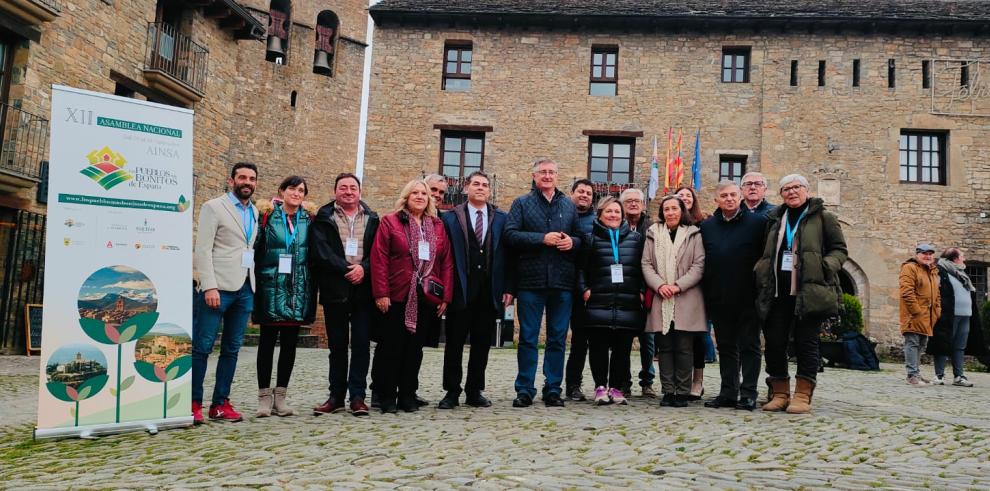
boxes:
[578,196,646,405]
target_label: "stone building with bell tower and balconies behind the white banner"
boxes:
[0,0,368,353]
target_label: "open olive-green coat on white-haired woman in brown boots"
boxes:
[756,198,849,319]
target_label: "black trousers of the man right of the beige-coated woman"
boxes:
[708,306,761,400]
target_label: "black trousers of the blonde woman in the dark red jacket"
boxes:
[373,301,436,404]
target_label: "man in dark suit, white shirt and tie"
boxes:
[437,171,515,409]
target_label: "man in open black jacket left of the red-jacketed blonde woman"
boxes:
[310,173,379,416]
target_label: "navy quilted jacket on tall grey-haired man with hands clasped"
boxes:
[505,189,581,290]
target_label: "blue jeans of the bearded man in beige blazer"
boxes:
[192,281,254,404]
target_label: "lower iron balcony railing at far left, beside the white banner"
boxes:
[0,103,48,179]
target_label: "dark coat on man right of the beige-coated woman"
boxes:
[701,209,767,312]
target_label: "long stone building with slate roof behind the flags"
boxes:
[365,0,990,345]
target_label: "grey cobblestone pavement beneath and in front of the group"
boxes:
[0,349,990,490]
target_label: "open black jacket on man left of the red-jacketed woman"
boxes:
[310,201,379,305]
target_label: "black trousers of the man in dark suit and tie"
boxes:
[443,298,496,396]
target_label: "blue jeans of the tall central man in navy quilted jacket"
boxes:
[515,289,573,398]
